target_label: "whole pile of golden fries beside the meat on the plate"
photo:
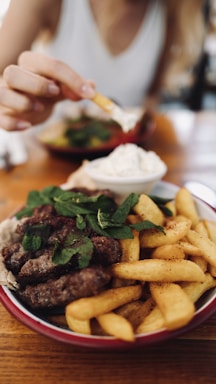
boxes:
[66,188,216,342]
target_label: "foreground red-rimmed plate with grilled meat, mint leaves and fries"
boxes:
[0,181,216,350]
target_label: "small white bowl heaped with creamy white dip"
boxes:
[85,143,167,198]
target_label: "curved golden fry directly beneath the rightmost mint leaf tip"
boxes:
[140,220,190,248]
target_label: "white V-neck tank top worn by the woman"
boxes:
[41,0,165,107]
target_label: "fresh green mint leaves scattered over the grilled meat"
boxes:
[16,186,166,268]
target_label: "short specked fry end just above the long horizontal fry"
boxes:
[151,244,185,260]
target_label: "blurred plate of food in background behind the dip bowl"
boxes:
[37,108,155,157]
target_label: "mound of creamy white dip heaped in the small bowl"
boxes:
[94,143,165,178]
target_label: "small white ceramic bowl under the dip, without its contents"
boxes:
[85,152,167,199]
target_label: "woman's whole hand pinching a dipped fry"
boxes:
[0,52,95,130]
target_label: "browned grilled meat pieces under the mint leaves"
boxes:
[2,200,122,309]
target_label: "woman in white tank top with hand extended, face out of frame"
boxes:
[0,0,208,130]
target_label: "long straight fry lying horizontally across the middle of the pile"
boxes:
[110,259,205,282]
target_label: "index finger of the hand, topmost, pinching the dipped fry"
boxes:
[19,52,95,100]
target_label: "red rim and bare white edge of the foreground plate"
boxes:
[0,182,216,350]
